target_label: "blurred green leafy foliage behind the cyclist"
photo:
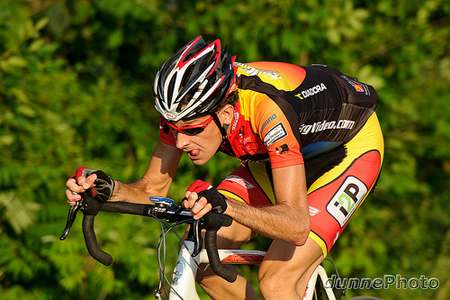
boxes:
[0,0,450,299]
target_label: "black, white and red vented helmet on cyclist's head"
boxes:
[153,36,237,122]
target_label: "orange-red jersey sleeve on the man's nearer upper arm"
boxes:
[252,94,304,169]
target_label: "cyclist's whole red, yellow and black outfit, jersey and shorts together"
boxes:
[160,62,384,256]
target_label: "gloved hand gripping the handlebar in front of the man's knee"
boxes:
[183,180,228,219]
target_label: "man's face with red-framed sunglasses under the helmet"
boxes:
[172,116,222,166]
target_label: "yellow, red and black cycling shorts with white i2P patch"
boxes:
[218,113,384,257]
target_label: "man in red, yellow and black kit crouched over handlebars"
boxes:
[66,36,384,299]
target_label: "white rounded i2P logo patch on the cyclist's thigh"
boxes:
[327,176,367,227]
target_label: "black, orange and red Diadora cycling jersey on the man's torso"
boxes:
[161,62,378,168]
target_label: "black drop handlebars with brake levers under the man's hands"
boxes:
[60,196,237,282]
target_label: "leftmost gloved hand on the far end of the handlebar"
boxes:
[66,167,114,205]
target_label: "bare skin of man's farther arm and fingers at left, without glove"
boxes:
[66,141,183,205]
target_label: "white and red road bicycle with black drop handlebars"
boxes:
[60,193,380,300]
